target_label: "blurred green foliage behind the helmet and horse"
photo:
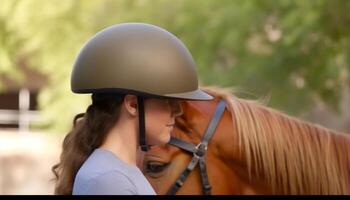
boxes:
[0,0,350,132]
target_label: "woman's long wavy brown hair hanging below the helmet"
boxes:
[52,93,124,195]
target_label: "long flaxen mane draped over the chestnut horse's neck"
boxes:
[202,87,350,194]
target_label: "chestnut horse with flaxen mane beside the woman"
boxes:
[141,87,350,195]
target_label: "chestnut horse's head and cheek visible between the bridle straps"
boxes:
[143,95,266,194]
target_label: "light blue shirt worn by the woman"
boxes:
[73,148,156,195]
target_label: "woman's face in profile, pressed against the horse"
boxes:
[145,99,182,145]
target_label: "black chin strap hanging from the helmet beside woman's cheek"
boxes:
[137,96,150,151]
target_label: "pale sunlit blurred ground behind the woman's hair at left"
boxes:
[0,130,63,195]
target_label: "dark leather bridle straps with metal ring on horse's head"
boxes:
[167,100,226,195]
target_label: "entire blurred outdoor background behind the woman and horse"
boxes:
[0,0,350,194]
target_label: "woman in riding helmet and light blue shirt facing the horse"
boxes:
[53,23,212,195]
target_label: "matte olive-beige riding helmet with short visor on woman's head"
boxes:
[71,23,213,100]
